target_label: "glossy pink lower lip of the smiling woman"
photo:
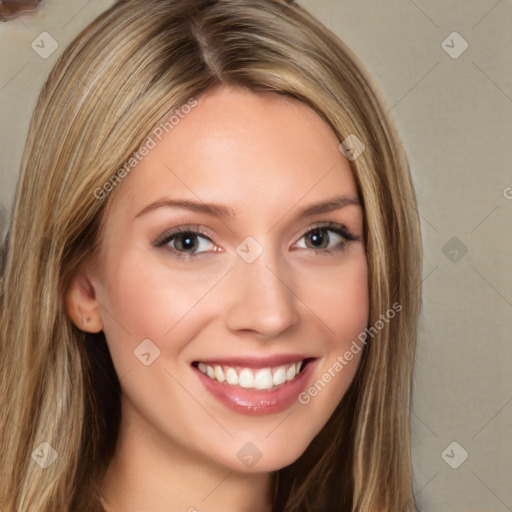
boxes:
[194,361,315,416]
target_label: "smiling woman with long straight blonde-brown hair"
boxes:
[0,0,421,512]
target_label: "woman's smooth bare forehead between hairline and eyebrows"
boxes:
[110,83,357,218]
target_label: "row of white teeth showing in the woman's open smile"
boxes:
[192,358,313,391]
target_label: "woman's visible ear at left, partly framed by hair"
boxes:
[65,265,103,332]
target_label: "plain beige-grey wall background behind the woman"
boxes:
[0,0,512,512]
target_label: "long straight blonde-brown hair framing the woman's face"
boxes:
[0,0,421,512]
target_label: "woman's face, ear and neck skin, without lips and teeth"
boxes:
[66,86,368,512]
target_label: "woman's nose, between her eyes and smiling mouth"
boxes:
[226,251,300,339]
